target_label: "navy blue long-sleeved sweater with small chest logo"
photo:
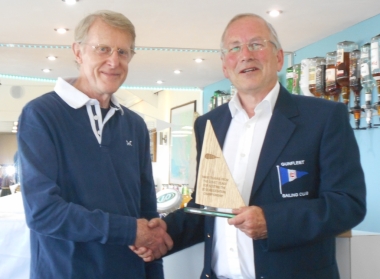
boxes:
[18,92,163,279]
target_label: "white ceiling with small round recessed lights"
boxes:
[0,0,380,133]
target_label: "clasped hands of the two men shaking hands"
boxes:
[129,218,173,262]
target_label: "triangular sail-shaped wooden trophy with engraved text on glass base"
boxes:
[184,120,245,218]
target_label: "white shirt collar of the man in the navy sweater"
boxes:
[54,77,123,114]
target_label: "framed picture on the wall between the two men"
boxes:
[169,101,197,184]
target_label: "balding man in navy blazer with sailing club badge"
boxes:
[137,14,366,279]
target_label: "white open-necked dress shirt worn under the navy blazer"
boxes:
[212,82,280,279]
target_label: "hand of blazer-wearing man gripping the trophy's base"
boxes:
[228,206,267,240]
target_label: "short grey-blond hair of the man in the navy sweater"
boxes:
[74,10,136,49]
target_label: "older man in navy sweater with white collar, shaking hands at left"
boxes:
[18,11,172,279]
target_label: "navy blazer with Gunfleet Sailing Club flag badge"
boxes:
[165,86,366,279]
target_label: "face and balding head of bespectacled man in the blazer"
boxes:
[222,17,284,96]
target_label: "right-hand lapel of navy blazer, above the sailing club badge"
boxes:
[251,86,298,200]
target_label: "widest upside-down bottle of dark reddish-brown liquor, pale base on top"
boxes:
[336,41,358,105]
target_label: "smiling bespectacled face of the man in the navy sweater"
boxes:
[73,19,132,107]
